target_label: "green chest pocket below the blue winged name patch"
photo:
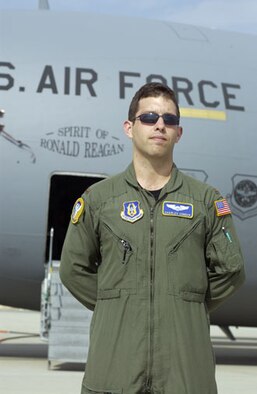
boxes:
[166,219,207,302]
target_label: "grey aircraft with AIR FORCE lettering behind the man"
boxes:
[0,4,257,334]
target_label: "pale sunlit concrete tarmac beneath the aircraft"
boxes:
[0,306,257,394]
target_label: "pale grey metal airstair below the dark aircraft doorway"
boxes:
[40,229,92,368]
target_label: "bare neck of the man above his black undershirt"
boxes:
[133,157,173,190]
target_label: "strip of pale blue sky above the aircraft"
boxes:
[0,0,257,35]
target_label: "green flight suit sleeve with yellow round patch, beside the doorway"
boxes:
[60,194,100,310]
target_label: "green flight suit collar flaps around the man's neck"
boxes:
[125,162,183,194]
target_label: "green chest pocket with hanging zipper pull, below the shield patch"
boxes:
[98,223,137,298]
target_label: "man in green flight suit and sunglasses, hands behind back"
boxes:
[60,83,244,394]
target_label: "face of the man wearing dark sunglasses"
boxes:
[124,96,182,160]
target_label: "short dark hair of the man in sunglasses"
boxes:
[128,82,180,122]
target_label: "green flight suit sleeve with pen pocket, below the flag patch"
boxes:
[206,192,245,312]
